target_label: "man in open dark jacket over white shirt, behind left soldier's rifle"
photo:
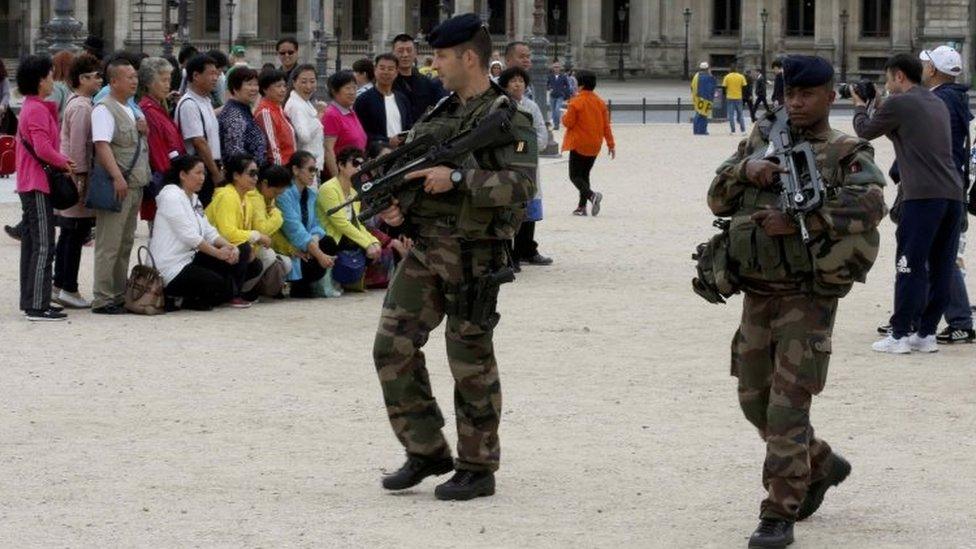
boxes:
[352,53,413,147]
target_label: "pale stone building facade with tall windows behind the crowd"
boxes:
[0,0,976,79]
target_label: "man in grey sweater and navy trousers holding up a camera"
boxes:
[851,54,964,354]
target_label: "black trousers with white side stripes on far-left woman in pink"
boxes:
[20,191,54,311]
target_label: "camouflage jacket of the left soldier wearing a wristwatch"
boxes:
[406,83,539,240]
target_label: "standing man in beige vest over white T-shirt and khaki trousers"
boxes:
[92,59,149,314]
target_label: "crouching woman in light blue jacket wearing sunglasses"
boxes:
[273,151,336,297]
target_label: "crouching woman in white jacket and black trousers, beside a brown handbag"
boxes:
[149,155,248,311]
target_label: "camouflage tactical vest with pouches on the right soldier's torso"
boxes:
[728,130,884,297]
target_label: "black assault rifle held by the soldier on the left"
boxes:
[327,101,516,221]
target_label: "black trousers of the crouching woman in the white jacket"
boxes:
[166,244,255,311]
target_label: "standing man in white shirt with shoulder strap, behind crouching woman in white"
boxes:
[174,55,224,207]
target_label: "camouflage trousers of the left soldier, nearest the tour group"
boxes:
[373,238,504,471]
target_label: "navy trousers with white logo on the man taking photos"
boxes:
[891,198,963,338]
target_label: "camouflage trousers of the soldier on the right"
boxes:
[732,293,837,520]
